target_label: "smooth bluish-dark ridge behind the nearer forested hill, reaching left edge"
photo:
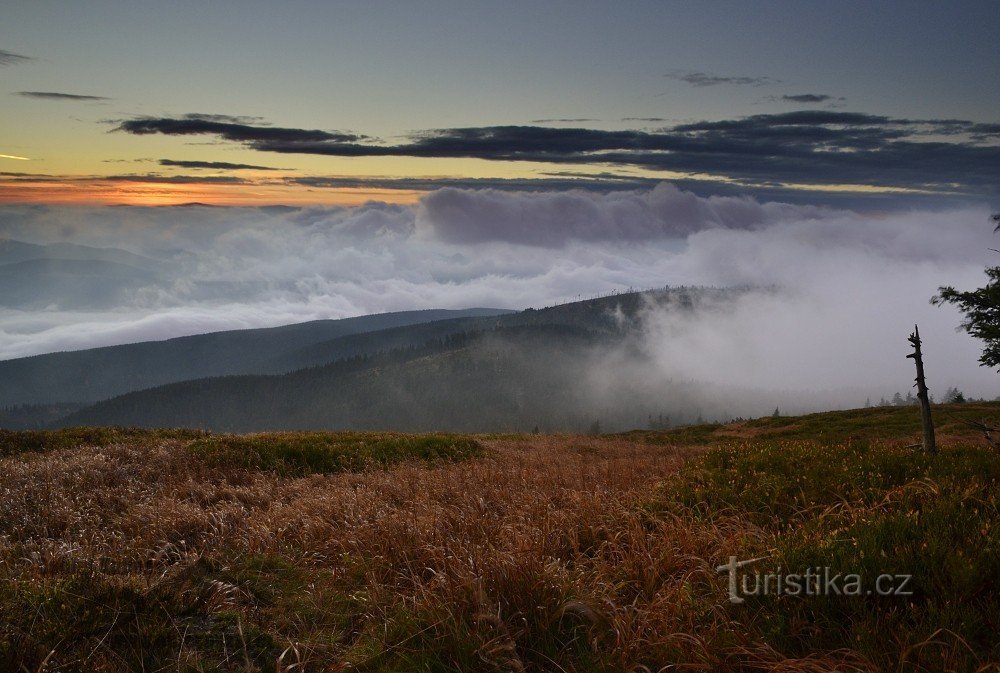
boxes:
[0,308,507,406]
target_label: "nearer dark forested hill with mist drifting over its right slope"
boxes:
[58,289,744,432]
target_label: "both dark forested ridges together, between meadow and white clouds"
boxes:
[0,288,745,432]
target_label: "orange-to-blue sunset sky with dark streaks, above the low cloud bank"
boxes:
[0,0,1000,209]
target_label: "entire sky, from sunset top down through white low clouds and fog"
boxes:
[0,0,1000,404]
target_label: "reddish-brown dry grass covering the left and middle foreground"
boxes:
[0,436,996,673]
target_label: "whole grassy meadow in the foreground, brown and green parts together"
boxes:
[0,404,1000,673]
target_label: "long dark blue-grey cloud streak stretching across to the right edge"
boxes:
[118,110,1000,196]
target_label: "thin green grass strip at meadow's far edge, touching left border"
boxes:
[0,427,208,458]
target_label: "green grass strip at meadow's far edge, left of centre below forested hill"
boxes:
[188,432,484,476]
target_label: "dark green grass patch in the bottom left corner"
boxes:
[0,561,282,671]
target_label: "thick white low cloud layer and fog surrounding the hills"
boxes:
[0,185,1000,404]
